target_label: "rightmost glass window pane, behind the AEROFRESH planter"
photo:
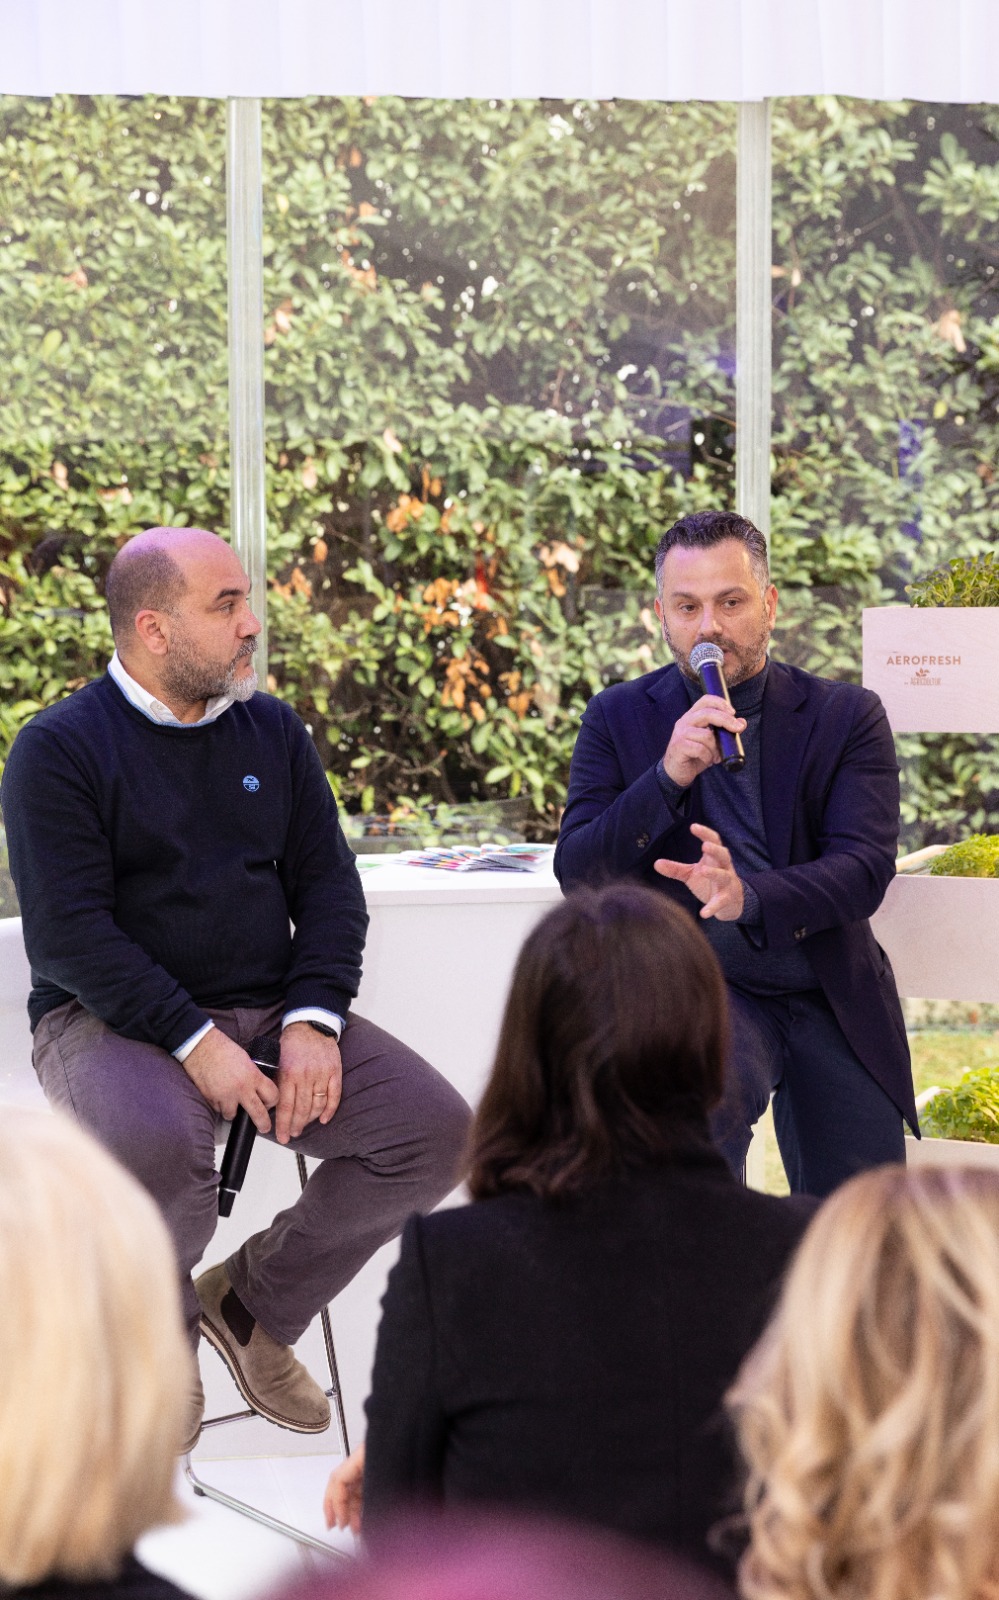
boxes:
[772,98,999,848]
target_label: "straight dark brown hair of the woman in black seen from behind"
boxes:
[469,882,728,1200]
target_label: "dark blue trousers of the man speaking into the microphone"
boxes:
[711,989,905,1195]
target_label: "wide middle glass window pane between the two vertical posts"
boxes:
[264,98,735,837]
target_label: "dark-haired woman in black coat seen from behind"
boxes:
[328,883,813,1558]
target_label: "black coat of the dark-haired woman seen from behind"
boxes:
[365,1146,815,1557]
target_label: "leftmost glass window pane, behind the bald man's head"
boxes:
[0,96,227,752]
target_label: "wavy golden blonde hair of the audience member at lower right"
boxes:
[728,1166,999,1600]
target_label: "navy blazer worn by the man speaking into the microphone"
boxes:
[556,661,917,1130]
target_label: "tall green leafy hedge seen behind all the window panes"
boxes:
[0,98,999,843]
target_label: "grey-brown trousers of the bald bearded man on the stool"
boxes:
[34,1000,471,1344]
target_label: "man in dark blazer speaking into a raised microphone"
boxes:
[556,512,917,1195]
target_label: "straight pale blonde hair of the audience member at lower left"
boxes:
[0,1110,192,1589]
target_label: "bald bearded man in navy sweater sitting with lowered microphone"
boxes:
[2,528,469,1448]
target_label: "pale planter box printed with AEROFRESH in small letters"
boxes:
[863,605,999,733]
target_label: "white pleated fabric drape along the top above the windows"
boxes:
[0,0,999,102]
